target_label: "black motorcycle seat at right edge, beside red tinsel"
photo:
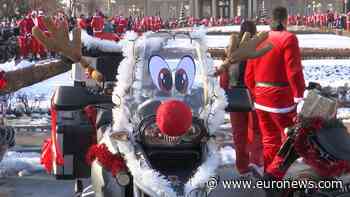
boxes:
[316,123,350,161]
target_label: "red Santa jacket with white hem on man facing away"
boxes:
[245,31,305,113]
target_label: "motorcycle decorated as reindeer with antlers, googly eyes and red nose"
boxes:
[33,19,270,197]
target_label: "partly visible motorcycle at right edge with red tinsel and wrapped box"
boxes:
[278,83,350,197]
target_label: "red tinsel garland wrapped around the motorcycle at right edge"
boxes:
[294,118,350,177]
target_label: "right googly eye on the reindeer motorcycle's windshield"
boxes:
[175,55,196,94]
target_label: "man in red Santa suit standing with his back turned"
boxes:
[245,7,305,185]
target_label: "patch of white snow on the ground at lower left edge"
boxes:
[0,151,44,178]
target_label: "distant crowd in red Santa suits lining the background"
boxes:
[0,10,350,59]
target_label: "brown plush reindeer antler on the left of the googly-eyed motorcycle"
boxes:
[32,17,103,82]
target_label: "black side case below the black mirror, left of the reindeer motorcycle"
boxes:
[53,110,96,180]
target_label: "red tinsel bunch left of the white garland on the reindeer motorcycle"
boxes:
[86,144,126,176]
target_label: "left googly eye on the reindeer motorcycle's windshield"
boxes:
[148,55,173,92]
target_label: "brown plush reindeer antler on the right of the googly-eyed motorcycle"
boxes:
[214,32,273,76]
